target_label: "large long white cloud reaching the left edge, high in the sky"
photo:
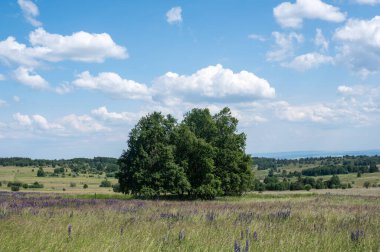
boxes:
[0,28,128,66]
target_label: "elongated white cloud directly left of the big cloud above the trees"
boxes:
[73,71,150,100]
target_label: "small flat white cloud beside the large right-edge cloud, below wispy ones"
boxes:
[283,52,334,71]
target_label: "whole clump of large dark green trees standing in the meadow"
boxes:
[117,108,253,199]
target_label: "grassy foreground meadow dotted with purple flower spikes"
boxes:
[0,192,380,251]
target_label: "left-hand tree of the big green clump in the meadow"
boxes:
[118,112,189,197]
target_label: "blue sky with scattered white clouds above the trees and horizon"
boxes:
[0,0,380,159]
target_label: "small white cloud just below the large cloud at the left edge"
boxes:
[14,67,49,89]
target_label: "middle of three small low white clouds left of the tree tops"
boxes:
[60,114,108,133]
